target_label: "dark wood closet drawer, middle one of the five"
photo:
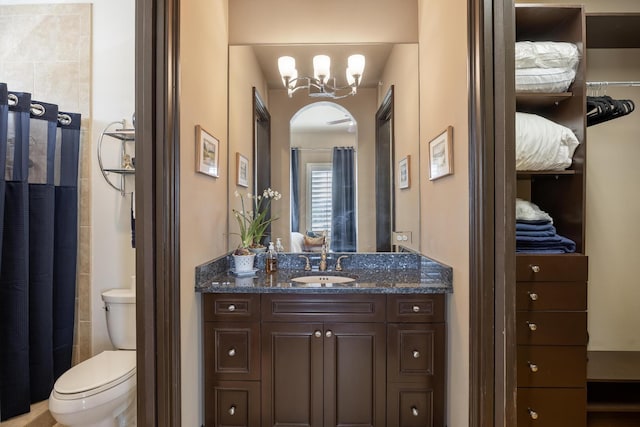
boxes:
[516,311,587,345]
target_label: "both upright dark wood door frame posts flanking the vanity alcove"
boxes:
[136,0,515,427]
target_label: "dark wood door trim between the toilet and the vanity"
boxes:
[135,0,181,426]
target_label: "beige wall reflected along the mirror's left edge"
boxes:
[228,46,269,249]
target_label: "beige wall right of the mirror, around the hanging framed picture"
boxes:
[419,0,469,427]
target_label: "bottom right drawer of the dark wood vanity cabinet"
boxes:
[387,383,444,427]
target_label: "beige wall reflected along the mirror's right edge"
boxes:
[378,43,421,251]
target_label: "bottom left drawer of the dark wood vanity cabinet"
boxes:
[204,381,260,427]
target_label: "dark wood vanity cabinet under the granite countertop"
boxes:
[203,294,445,427]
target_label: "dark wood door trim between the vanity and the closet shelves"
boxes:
[468,0,516,427]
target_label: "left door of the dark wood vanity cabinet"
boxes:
[261,322,325,427]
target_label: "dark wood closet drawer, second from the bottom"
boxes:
[517,346,587,387]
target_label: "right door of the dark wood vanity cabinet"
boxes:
[324,323,386,427]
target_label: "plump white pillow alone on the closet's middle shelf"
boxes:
[516,113,580,171]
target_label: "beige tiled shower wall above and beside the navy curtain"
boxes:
[0,4,92,364]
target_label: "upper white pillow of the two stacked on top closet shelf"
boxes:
[516,41,580,71]
